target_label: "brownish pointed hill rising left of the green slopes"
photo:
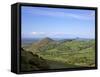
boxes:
[28,37,56,53]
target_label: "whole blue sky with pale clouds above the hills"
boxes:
[21,6,95,38]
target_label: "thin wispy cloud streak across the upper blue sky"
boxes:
[26,8,95,20]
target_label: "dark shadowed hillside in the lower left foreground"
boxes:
[21,48,49,71]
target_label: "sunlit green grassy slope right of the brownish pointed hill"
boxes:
[39,40,95,67]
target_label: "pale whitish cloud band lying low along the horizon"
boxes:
[22,31,95,38]
